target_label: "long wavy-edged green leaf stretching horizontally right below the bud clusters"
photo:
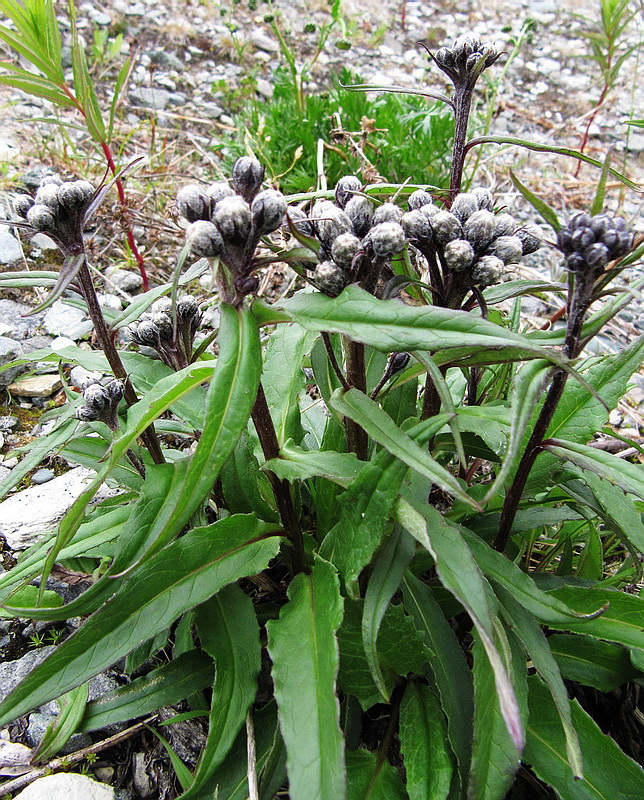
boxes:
[262,286,560,363]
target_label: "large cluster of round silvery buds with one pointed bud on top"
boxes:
[177,156,286,302]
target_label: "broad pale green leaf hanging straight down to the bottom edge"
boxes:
[266,558,345,800]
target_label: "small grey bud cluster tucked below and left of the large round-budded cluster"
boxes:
[128,295,202,370]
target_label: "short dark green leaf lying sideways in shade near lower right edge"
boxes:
[548,633,640,692]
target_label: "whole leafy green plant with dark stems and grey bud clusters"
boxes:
[0,28,644,800]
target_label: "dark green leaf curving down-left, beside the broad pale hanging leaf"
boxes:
[181,584,262,800]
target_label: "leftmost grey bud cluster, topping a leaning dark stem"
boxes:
[14,175,96,255]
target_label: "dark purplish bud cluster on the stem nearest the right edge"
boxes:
[557,211,633,279]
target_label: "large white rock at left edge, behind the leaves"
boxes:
[0,467,119,550]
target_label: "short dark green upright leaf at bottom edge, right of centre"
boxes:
[400,681,454,800]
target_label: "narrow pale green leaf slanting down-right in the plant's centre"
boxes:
[330,389,479,509]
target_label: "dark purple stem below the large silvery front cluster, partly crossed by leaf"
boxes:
[251,383,304,574]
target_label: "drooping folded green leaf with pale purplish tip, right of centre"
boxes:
[396,498,524,753]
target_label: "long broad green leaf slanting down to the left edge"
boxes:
[0,515,279,725]
